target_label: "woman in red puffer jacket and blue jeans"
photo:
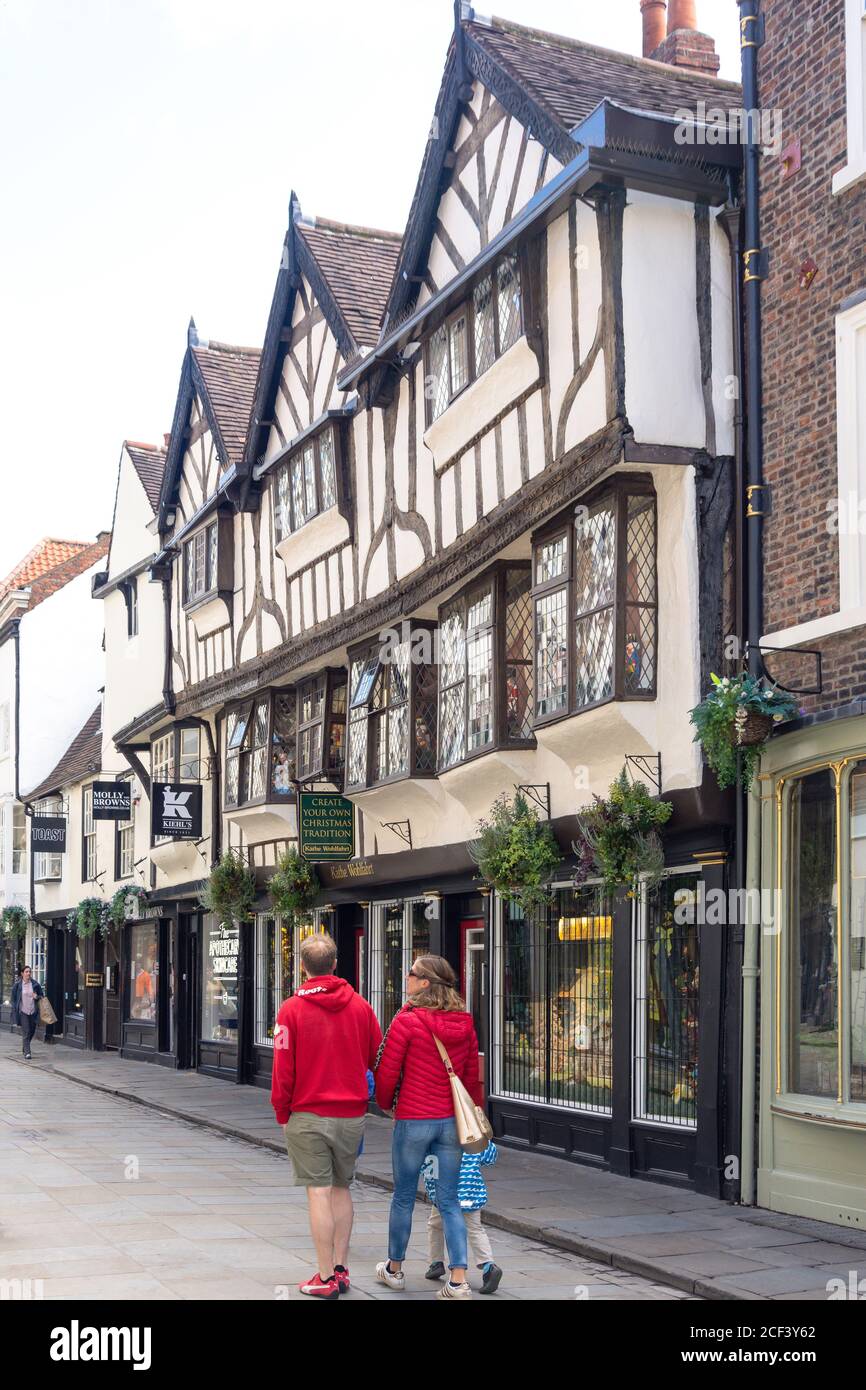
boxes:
[375,956,481,1298]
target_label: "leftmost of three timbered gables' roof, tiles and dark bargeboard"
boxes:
[158,328,261,530]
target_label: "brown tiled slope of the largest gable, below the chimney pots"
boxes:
[466,14,740,131]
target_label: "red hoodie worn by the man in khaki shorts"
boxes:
[271,974,382,1125]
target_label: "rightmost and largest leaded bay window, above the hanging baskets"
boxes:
[532,478,657,723]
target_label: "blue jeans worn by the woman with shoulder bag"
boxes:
[388,1118,468,1269]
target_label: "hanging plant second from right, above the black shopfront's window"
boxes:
[571,767,674,898]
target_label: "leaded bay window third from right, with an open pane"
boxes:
[346,623,436,788]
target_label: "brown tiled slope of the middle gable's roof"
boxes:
[296,218,400,348]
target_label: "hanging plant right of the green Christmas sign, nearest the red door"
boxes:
[468,792,562,913]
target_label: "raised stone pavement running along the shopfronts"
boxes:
[6,1033,866,1300]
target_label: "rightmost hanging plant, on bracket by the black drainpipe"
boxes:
[689,673,802,791]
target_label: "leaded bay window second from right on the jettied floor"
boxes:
[439,563,532,770]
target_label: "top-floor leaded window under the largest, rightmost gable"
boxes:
[425,256,523,424]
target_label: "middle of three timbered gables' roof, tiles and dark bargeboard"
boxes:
[243,193,400,468]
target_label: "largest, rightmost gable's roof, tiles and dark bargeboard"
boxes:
[385,7,741,333]
